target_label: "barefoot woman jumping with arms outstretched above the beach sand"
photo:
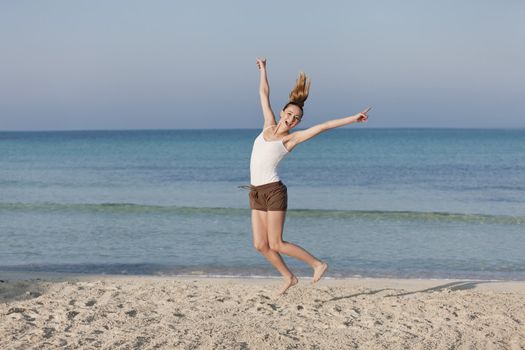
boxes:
[249,58,370,295]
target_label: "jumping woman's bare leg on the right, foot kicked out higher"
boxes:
[268,211,328,282]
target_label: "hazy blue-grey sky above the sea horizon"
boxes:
[0,0,525,131]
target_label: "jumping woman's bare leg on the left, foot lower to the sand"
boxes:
[252,209,298,294]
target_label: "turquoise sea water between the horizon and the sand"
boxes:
[0,128,525,280]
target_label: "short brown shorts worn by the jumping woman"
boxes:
[249,181,288,211]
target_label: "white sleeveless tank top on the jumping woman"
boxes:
[250,126,289,186]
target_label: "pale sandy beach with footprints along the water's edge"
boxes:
[0,272,525,349]
